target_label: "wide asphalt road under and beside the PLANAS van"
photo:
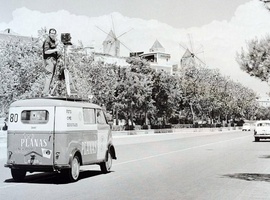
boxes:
[0,131,270,200]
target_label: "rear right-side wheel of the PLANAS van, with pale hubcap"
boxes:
[62,155,80,182]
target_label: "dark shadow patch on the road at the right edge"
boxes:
[223,173,270,182]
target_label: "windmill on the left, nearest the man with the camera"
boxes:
[97,15,132,57]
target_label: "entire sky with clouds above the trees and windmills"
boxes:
[0,0,270,96]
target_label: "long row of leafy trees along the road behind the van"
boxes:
[0,29,262,128]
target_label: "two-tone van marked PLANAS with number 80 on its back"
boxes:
[5,97,116,181]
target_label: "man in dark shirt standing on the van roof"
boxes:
[43,28,59,96]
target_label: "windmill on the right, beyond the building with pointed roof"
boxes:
[179,34,205,67]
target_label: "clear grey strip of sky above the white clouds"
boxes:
[0,0,249,28]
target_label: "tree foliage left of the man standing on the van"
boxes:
[0,38,43,115]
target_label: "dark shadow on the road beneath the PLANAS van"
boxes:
[4,170,107,185]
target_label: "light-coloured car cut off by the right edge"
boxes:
[254,120,270,142]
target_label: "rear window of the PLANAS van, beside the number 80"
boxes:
[21,110,49,124]
